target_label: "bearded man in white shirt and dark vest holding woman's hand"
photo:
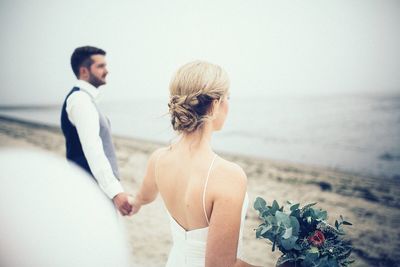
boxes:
[61,46,132,216]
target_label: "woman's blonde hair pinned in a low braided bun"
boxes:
[168,61,229,133]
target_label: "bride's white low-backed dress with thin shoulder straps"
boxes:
[166,155,248,267]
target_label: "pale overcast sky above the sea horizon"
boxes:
[0,0,400,105]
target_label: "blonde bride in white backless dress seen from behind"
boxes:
[134,61,260,267]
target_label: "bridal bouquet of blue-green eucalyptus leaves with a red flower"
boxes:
[254,197,353,267]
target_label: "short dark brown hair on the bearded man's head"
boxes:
[71,46,106,78]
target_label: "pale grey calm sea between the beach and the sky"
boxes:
[0,94,400,179]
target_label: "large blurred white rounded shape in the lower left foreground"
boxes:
[0,149,128,267]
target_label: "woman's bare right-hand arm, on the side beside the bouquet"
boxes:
[206,164,260,267]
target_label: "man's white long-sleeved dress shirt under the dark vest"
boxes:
[66,80,124,199]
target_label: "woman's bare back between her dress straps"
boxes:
[155,147,218,231]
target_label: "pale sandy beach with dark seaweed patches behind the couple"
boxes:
[0,116,400,267]
